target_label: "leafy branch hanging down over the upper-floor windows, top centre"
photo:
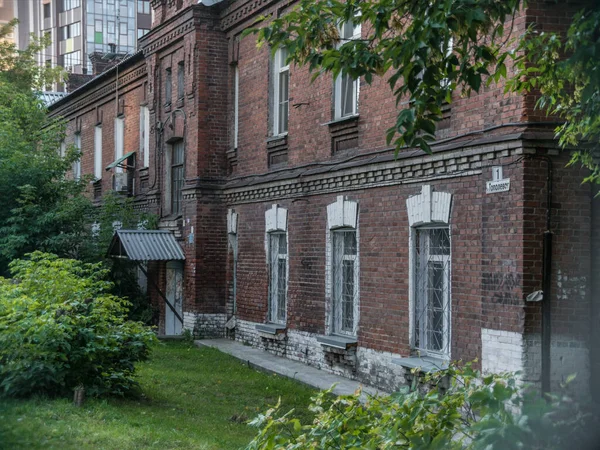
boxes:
[247,0,520,152]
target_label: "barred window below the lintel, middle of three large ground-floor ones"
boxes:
[331,229,358,334]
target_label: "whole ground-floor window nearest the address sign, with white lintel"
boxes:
[406,185,452,359]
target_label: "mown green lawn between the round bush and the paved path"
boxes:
[0,342,315,450]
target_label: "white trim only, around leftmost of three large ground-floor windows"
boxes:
[264,204,290,325]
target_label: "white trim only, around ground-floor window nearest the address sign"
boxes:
[406,185,452,359]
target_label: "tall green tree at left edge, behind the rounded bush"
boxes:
[0,21,93,274]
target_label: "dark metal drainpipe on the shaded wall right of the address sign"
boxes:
[542,156,553,394]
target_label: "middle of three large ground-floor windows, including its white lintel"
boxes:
[325,196,360,336]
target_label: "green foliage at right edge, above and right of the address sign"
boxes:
[509,8,600,184]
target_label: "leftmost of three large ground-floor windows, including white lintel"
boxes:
[265,205,289,325]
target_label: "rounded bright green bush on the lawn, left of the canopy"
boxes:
[0,252,156,397]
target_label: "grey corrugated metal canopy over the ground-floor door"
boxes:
[108,230,185,261]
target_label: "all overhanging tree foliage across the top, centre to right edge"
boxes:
[248,0,600,181]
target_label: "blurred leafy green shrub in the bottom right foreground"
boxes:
[247,364,593,450]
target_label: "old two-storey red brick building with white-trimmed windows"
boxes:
[51,0,600,400]
